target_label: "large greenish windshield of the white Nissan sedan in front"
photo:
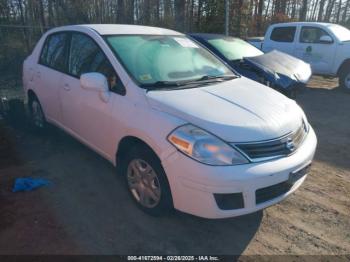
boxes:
[106,35,235,87]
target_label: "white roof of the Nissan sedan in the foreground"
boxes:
[46,24,183,35]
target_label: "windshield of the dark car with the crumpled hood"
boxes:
[207,37,264,61]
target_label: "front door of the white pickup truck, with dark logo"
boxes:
[295,26,337,74]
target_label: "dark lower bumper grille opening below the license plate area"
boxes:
[255,181,293,204]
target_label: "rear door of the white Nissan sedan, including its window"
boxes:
[34,32,68,122]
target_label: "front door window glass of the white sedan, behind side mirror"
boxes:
[68,33,124,93]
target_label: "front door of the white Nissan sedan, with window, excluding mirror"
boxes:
[60,32,124,155]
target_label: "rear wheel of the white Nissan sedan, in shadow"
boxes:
[28,97,47,132]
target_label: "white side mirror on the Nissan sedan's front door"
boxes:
[80,73,109,103]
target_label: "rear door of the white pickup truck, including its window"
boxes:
[263,26,297,55]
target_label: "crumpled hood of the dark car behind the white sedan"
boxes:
[243,50,312,87]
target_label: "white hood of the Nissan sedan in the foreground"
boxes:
[147,77,303,142]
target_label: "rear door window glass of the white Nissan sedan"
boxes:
[39,33,68,72]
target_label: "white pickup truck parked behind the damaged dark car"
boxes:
[248,22,350,91]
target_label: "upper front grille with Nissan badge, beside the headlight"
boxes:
[235,121,307,160]
